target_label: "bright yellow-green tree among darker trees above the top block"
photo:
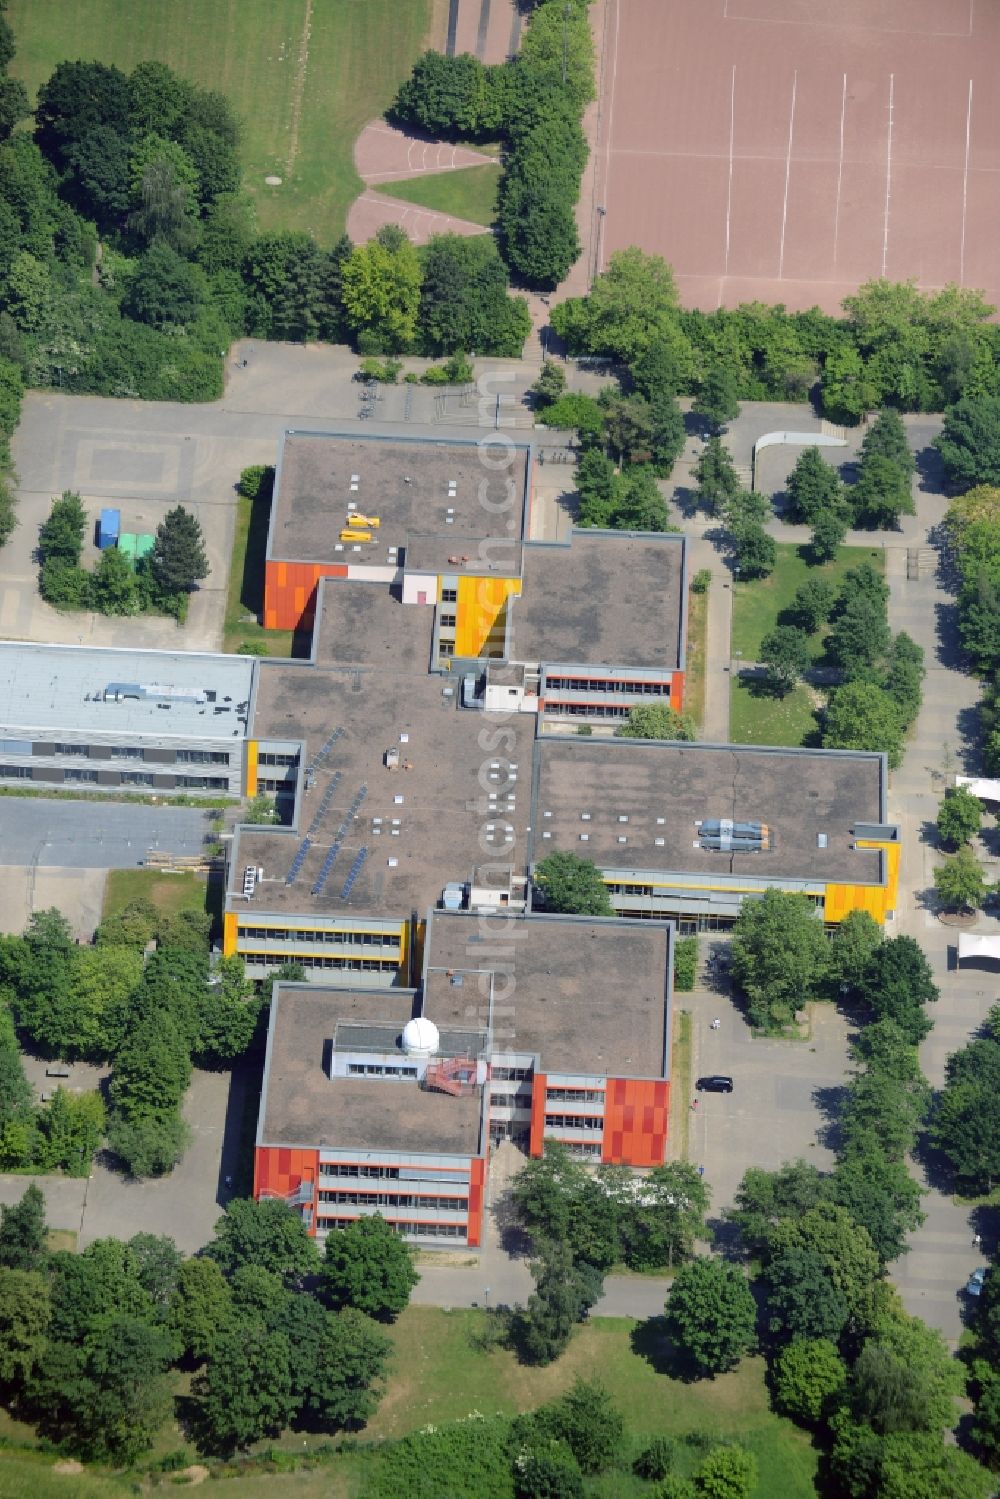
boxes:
[340,225,421,354]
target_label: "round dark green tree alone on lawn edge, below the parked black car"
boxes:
[666,1258,757,1376]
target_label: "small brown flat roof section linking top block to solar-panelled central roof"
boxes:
[313,577,435,678]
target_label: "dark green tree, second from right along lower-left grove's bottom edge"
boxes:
[192,1322,295,1454]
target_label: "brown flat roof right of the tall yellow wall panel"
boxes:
[508,531,685,669]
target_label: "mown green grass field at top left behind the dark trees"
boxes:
[7,0,432,244]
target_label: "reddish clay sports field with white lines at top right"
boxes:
[589,0,1000,312]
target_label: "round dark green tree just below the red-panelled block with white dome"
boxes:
[322,1213,420,1322]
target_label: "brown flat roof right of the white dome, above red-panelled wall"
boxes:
[423,911,670,1078]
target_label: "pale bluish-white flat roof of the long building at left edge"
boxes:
[0,640,256,739]
